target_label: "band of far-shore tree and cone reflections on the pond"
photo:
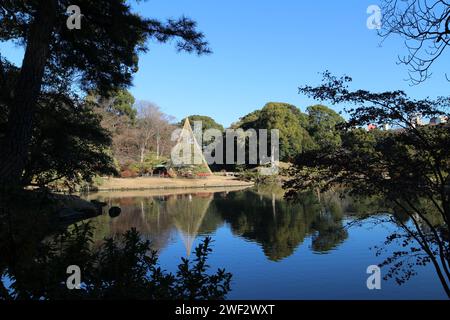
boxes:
[83,186,380,261]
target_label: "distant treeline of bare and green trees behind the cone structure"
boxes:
[93,90,344,177]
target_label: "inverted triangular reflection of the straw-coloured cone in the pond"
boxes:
[167,194,213,257]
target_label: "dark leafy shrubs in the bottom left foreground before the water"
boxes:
[0,224,231,300]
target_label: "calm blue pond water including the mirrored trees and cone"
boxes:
[87,187,446,299]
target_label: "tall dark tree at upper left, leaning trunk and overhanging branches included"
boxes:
[0,0,209,186]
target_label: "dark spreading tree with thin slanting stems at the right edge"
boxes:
[286,72,450,297]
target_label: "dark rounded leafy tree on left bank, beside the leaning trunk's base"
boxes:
[0,83,116,188]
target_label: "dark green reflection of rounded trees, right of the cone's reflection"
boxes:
[214,192,347,261]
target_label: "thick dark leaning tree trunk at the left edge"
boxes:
[0,0,56,187]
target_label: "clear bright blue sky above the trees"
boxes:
[0,0,450,126]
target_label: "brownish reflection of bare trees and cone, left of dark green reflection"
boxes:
[89,193,217,255]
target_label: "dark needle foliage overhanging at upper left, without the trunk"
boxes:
[0,0,209,95]
